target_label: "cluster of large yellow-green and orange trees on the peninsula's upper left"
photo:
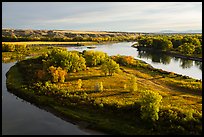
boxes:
[36,49,120,83]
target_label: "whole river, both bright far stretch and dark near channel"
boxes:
[2,42,202,135]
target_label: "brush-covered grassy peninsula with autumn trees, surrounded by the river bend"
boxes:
[7,49,202,135]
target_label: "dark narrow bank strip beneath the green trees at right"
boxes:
[132,45,202,62]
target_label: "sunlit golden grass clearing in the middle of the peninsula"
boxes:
[56,67,202,113]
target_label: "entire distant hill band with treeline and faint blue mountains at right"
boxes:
[2,28,202,42]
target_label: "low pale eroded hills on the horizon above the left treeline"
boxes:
[2,29,140,38]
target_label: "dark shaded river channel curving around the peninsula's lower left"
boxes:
[2,63,104,135]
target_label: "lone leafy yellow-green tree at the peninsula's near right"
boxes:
[140,90,162,121]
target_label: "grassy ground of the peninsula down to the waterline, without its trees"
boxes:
[7,53,202,135]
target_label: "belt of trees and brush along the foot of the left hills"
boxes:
[2,30,140,42]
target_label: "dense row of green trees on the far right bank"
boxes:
[138,34,202,58]
